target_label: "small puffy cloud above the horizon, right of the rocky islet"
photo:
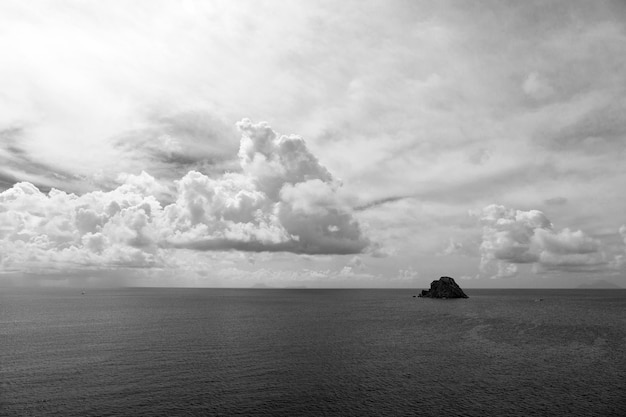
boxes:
[480,204,607,278]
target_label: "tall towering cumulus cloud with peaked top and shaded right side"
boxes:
[165,119,369,253]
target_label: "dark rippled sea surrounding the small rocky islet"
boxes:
[0,289,626,416]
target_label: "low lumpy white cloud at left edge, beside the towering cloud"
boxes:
[0,183,160,271]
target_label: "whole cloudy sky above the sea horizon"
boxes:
[0,0,626,288]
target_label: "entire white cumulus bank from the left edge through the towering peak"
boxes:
[0,120,369,270]
